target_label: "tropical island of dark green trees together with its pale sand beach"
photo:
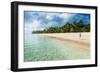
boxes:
[32,20,90,47]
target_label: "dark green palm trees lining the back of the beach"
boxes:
[32,20,90,33]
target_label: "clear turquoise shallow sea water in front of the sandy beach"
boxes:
[24,34,90,62]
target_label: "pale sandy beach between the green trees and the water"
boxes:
[35,32,90,49]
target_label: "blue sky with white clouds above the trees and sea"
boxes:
[24,11,90,33]
